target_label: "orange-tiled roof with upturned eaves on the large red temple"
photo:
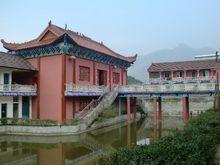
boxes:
[1,23,137,62]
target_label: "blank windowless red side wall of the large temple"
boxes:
[29,55,62,121]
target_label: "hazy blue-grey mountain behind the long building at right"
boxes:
[128,44,216,82]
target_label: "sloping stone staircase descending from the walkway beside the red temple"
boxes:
[81,86,119,127]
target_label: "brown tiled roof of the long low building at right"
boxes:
[148,60,220,72]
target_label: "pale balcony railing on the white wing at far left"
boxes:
[0,84,37,93]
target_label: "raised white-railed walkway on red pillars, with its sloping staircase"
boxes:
[79,81,216,127]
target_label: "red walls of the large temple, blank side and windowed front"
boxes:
[29,55,127,122]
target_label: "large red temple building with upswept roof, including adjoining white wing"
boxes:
[0,22,137,122]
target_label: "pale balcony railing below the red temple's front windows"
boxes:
[65,83,108,95]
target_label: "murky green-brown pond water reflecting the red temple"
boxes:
[0,117,184,165]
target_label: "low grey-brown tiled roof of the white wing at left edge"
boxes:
[0,52,36,71]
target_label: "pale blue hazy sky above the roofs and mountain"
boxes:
[0,0,220,55]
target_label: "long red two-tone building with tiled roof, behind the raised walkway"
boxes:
[148,60,220,83]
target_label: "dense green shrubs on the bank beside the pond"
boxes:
[101,111,220,165]
